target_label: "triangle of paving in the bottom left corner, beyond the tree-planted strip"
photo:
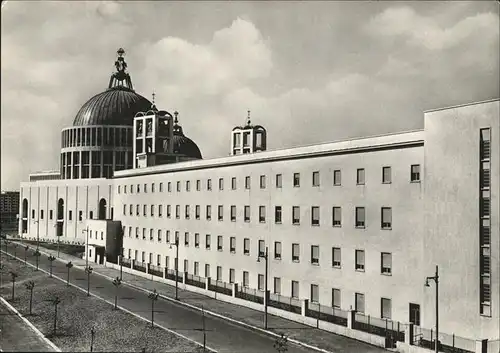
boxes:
[0,302,54,352]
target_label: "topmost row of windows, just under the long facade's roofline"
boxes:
[118,164,420,194]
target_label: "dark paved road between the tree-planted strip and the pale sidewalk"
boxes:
[2,246,316,353]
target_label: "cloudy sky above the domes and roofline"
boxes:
[0,0,500,190]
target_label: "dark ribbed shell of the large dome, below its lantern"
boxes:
[73,86,151,126]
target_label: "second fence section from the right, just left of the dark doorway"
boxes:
[353,313,405,348]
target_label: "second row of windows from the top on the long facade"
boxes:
[123,204,392,229]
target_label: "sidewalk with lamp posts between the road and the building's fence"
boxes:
[13,241,386,353]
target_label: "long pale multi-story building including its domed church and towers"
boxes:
[19,48,500,350]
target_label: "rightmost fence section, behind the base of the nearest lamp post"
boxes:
[413,326,474,353]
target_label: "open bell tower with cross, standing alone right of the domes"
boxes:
[231,110,267,156]
